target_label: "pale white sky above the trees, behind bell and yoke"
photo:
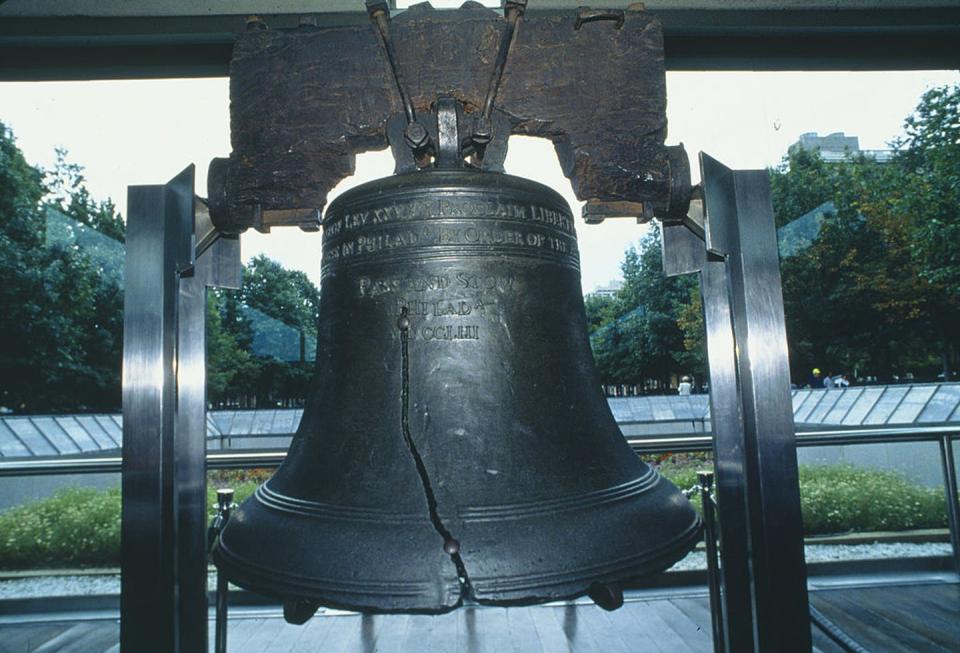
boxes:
[0,71,960,292]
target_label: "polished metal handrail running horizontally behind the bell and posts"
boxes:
[0,426,960,477]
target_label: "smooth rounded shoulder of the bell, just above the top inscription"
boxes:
[321,168,573,226]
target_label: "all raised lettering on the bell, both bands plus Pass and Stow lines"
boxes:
[323,197,579,342]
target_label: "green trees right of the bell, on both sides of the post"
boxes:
[587,85,960,385]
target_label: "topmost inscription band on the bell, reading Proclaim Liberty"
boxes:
[323,197,574,237]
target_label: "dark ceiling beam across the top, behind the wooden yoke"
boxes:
[0,5,960,80]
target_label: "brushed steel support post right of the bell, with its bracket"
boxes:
[663,154,811,651]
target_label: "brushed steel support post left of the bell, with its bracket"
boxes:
[120,165,240,651]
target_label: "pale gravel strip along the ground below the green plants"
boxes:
[0,542,952,600]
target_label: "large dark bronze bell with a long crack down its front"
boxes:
[214,90,700,622]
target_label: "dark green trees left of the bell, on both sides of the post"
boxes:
[0,119,319,413]
